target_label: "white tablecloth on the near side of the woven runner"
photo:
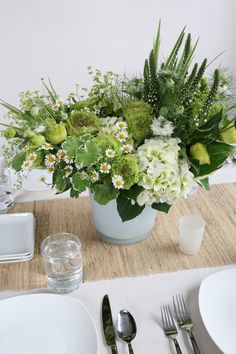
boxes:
[0,264,236,354]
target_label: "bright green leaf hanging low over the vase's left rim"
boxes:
[92,179,119,205]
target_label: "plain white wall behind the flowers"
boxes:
[0,0,236,151]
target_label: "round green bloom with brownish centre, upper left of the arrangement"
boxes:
[70,111,100,135]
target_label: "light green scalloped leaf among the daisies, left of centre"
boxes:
[76,140,100,166]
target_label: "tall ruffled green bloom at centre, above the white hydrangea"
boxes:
[124,101,153,143]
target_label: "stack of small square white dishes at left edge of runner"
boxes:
[0,213,35,260]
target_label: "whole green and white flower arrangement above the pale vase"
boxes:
[1,25,236,221]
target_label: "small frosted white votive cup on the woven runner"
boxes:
[179,214,205,255]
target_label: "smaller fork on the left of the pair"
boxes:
[161,305,182,354]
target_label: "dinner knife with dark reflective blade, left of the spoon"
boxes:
[102,295,118,354]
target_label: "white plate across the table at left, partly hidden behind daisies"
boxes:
[9,168,52,191]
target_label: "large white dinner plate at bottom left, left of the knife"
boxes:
[0,294,97,354]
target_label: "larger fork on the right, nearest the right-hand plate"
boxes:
[173,295,201,354]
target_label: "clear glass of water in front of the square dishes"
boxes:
[41,232,83,293]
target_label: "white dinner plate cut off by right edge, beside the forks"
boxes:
[199,269,236,354]
